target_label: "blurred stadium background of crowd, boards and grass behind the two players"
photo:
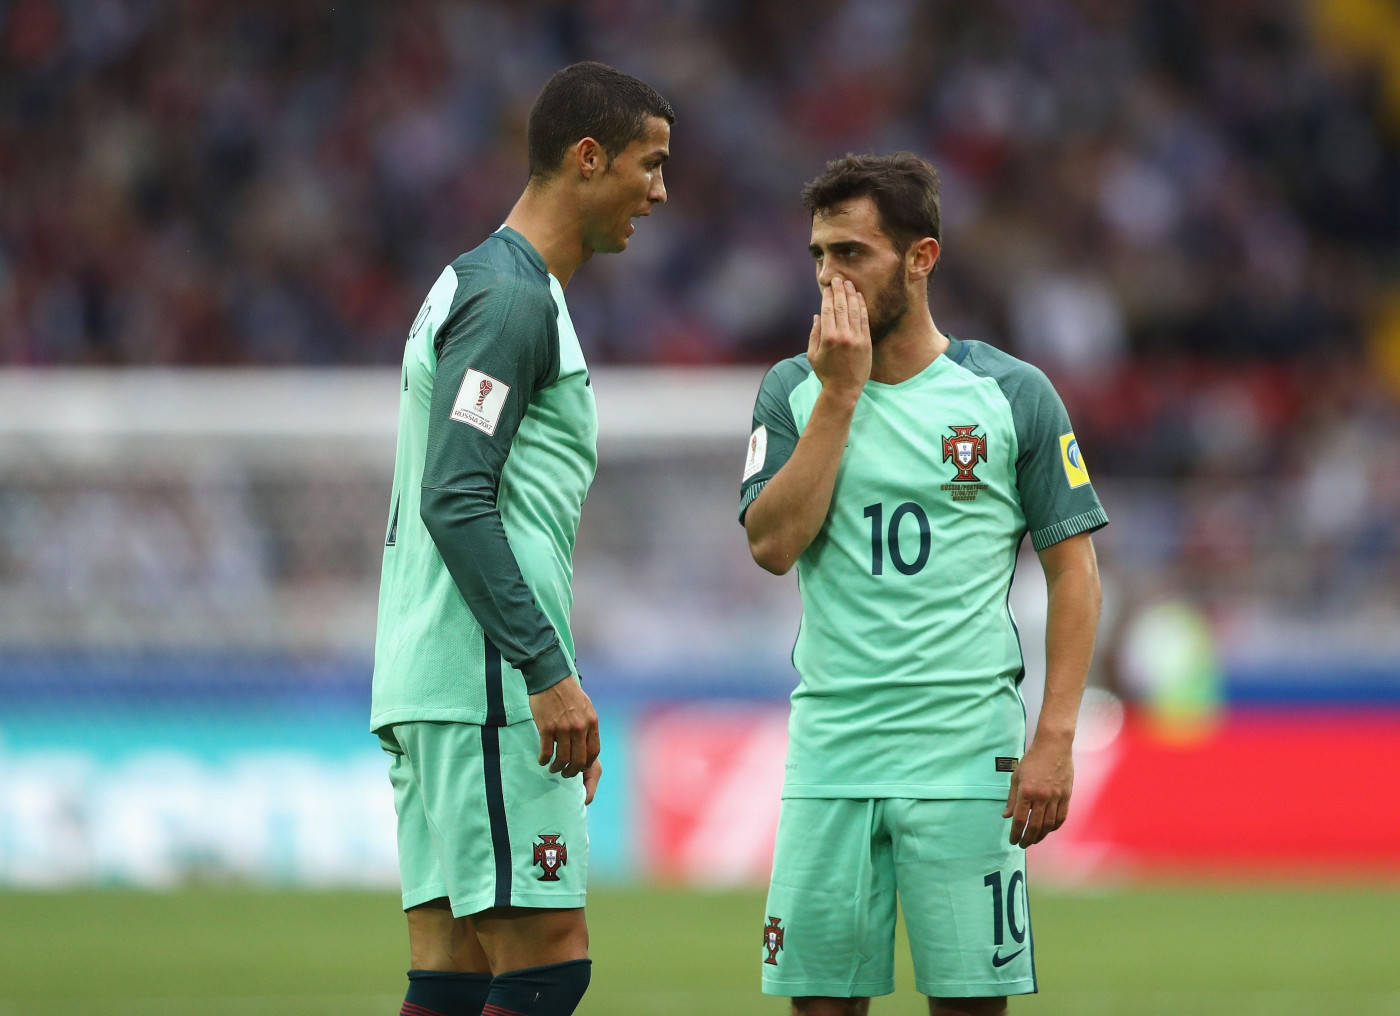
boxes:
[0,0,1400,1013]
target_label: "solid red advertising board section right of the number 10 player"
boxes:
[1047,711,1400,875]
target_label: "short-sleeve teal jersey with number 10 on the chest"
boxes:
[739,339,1109,798]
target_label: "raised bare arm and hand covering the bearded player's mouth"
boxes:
[743,277,871,575]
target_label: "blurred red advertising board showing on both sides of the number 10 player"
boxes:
[634,704,1400,883]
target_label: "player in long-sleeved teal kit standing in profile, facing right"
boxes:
[371,63,675,1016]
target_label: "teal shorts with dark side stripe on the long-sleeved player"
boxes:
[379,719,588,917]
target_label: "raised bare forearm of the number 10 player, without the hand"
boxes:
[743,390,858,575]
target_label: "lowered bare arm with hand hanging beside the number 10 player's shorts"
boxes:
[1007,533,1100,847]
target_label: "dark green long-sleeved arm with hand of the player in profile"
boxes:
[420,277,598,777]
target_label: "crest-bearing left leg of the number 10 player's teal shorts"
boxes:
[760,798,895,998]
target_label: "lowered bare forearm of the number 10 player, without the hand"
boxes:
[1036,558,1100,743]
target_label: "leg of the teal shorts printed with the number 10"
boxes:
[888,799,1036,998]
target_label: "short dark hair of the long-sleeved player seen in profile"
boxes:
[526,60,676,179]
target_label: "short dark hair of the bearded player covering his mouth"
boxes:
[802,151,942,253]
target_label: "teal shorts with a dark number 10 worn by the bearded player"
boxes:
[762,798,1036,998]
